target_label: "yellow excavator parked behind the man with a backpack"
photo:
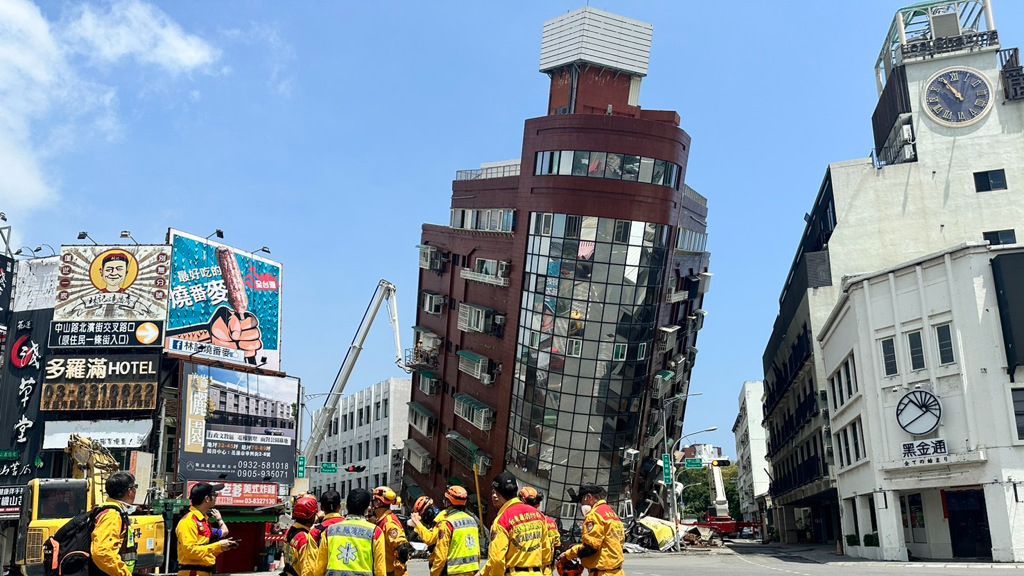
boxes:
[15,435,165,576]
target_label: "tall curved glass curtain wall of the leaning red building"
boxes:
[509,213,670,517]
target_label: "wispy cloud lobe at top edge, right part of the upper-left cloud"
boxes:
[63,0,220,74]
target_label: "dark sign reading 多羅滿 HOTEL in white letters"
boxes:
[40,354,160,411]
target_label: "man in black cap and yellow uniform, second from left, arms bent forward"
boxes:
[174,482,239,576]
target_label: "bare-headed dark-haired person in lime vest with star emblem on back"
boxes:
[314,488,387,576]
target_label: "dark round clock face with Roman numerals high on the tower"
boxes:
[925,68,992,126]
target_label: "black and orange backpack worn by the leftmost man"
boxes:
[43,504,131,576]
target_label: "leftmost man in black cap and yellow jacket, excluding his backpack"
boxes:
[89,471,138,576]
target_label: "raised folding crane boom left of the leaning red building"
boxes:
[304,280,410,460]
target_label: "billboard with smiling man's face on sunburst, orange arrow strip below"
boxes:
[49,246,171,347]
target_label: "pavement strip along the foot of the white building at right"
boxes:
[726,541,1024,570]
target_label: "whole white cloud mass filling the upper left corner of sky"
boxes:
[0,0,219,220]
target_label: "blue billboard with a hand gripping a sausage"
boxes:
[165,230,282,371]
